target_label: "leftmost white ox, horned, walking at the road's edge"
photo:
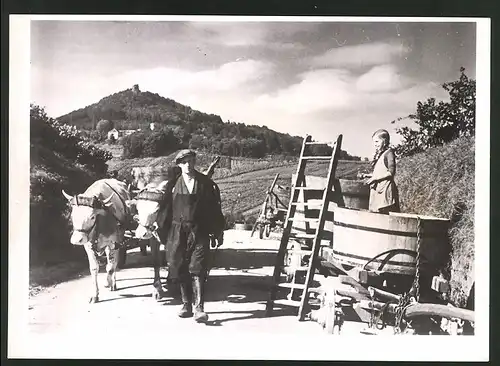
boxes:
[62,179,130,303]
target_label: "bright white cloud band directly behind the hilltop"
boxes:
[31,59,274,117]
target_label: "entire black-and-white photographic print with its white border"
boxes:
[9,15,491,361]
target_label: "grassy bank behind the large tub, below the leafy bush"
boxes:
[396,138,475,306]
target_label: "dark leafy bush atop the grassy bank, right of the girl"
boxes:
[392,67,476,156]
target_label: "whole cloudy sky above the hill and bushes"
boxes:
[31,18,476,157]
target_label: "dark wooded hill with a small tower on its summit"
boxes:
[57,85,360,160]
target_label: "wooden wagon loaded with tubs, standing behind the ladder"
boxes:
[283,176,474,334]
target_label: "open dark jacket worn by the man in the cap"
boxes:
[160,167,225,242]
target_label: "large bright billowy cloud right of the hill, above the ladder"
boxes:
[255,65,442,115]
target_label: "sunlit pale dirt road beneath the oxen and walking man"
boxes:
[21,230,394,357]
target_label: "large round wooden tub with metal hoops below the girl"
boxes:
[332,207,449,275]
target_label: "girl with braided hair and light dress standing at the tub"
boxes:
[364,130,400,213]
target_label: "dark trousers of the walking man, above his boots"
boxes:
[167,222,210,282]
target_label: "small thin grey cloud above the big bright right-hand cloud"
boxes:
[311,42,410,68]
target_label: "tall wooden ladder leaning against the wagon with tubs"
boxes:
[266,135,342,320]
